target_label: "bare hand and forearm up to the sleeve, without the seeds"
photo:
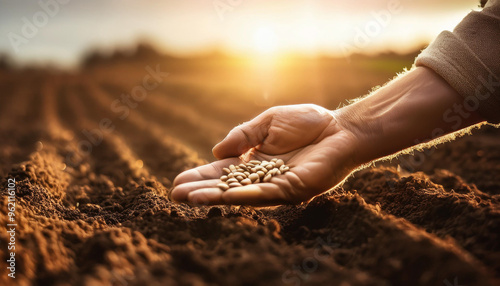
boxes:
[171,67,484,205]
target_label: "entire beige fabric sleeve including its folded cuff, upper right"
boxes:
[415,0,500,123]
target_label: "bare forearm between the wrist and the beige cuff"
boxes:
[335,67,483,164]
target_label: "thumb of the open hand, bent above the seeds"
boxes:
[212,113,272,160]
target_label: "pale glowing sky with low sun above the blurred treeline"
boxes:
[0,0,479,67]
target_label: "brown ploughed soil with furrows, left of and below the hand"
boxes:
[0,61,500,285]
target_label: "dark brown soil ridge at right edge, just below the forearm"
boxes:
[344,168,500,278]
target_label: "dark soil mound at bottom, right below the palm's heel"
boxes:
[269,190,487,285]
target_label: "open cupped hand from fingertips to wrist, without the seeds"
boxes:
[170,104,357,206]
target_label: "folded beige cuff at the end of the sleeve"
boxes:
[415,31,500,123]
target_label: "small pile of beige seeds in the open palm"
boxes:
[217,158,290,191]
